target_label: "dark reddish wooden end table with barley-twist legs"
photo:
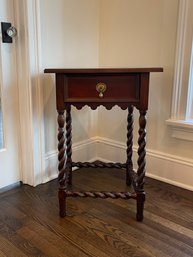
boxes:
[44,68,163,221]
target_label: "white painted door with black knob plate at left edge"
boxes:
[0,0,21,188]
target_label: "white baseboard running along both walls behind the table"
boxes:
[43,137,193,191]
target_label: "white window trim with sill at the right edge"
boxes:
[166,0,193,141]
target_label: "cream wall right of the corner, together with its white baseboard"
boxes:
[95,0,193,190]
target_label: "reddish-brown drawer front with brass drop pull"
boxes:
[65,74,140,102]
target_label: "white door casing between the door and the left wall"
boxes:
[14,0,45,186]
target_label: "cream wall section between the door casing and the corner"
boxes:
[40,0,99,152]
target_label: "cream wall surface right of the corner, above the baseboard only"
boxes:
[99,0,193,158]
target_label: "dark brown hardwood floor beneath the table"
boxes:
[0,169,193,257]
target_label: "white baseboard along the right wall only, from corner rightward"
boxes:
[98,137,193,191]
